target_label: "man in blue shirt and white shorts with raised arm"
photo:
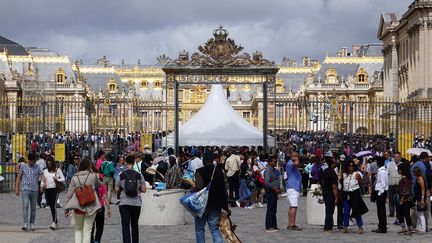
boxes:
[285,152,302,231]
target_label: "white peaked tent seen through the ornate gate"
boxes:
[164,85,274,146]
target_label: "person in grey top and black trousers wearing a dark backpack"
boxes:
[115,156,146,243]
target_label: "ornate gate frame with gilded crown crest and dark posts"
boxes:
[162,26,279,154]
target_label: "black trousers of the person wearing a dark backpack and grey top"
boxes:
[119,205,141,243]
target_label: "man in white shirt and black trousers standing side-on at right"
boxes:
[372,157,388,233]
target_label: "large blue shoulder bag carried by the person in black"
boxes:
[180,166,216,218]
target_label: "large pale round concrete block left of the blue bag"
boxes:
[138,189,185,225]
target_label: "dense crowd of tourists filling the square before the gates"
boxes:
[8,131,432,242]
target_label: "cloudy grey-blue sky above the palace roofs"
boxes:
[0,0,413,64]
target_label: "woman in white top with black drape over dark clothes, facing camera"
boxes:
[342,160,368,234]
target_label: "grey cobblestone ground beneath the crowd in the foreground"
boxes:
[0,194,432,243]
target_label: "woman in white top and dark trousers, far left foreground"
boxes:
[43,156,65,230]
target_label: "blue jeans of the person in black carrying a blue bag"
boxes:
[195,209,223,243]
